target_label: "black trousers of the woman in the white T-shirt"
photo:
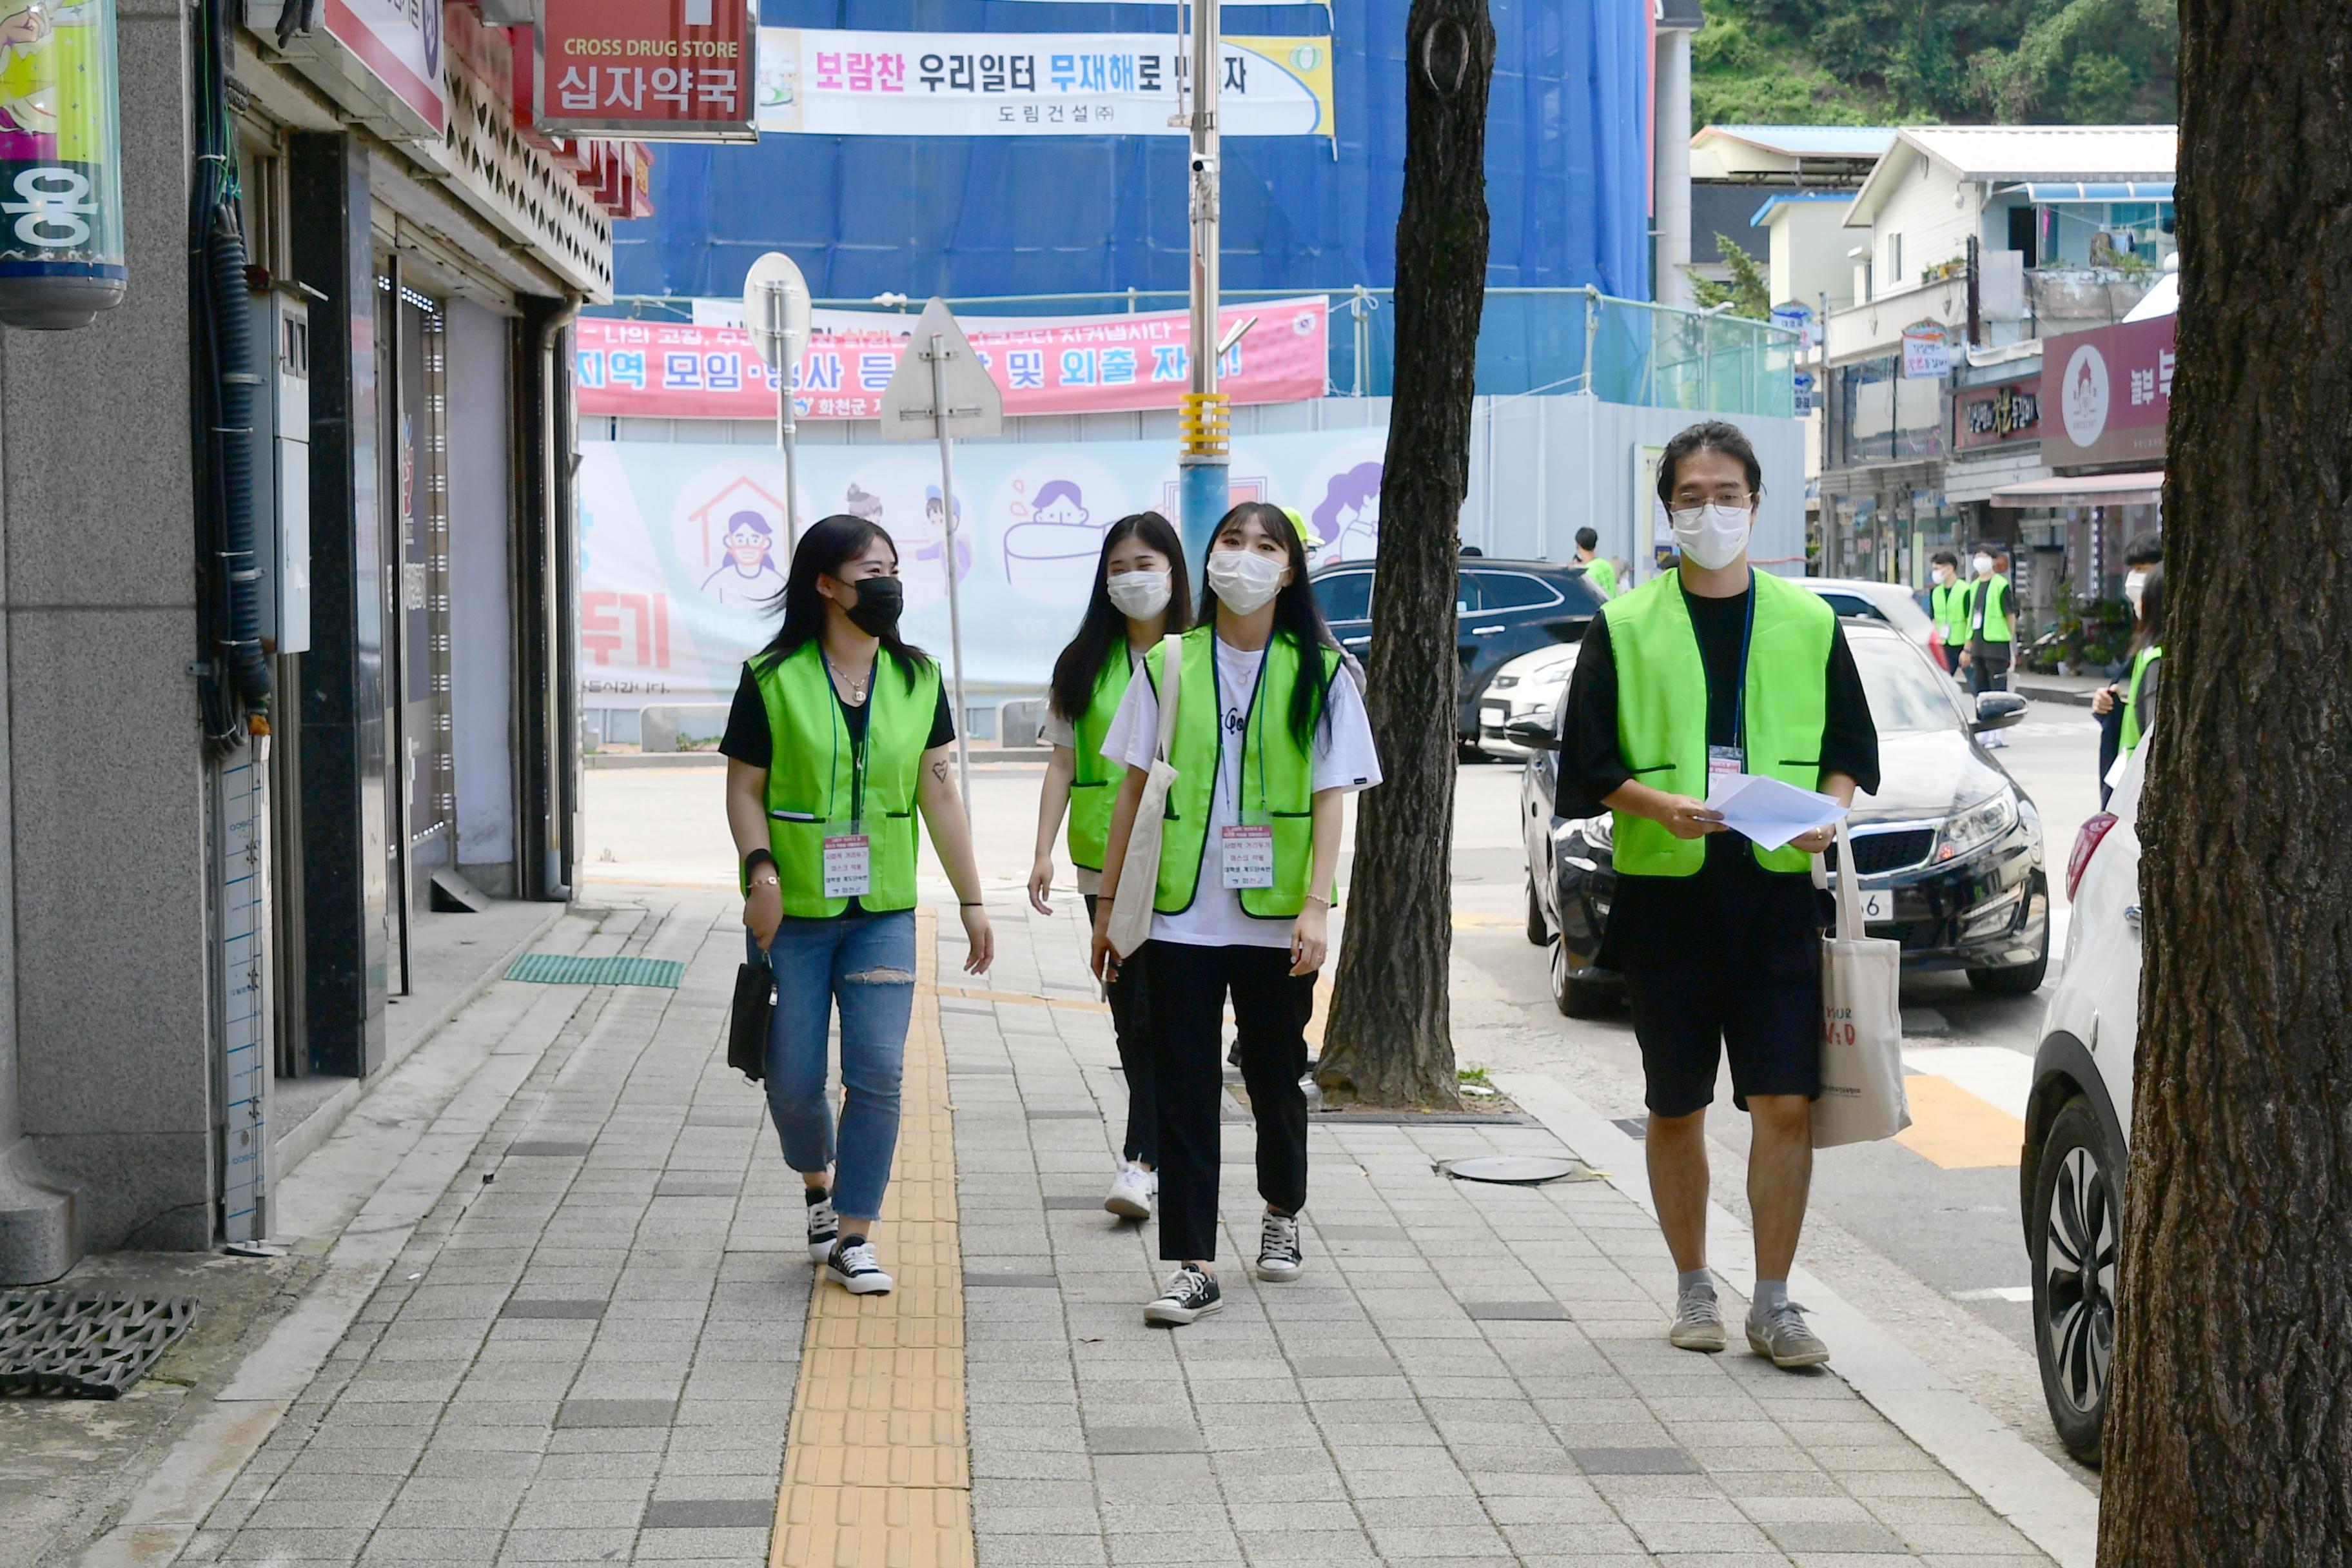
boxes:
[1143,943,1315,1262]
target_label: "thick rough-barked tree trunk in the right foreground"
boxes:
[2098,0,2352,1568]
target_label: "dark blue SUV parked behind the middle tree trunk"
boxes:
[1310,554,1602,745]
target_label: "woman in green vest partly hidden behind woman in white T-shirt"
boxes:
[1030,513,1193,1220]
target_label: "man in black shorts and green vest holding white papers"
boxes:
[1557,421,1879,1366]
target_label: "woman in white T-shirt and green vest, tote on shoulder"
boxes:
[1093,501,1380,1326]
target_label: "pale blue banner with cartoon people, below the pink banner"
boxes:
[578,426,1387,707]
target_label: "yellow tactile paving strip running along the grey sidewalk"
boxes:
[767,912,974,1568]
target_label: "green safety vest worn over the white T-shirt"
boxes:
[1143,625,1338,919]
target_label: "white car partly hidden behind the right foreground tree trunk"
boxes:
[2018,743,2148,1465]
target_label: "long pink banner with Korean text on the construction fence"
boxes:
[576,296,1331,418]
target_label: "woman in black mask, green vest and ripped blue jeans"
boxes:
[720,513,995,1295]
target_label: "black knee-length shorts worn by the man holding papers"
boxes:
[1625,959,1821,1117]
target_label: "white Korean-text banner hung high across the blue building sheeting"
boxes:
[760,28,1338,136]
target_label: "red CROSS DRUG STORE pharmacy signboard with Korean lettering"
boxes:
[534,0,760,141]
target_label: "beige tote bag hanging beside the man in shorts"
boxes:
[1814,821,1910,1150]
